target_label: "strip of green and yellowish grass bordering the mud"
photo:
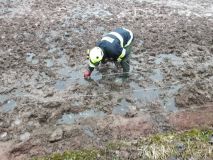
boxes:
[34,129,213,160]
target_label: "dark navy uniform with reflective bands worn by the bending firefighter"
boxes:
[89,28,133,77]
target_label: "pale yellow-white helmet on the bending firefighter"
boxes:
[89,47,104,63]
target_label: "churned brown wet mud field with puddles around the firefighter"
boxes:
[0,0,213,159]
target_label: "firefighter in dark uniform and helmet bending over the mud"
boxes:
[84,28,133,79]
